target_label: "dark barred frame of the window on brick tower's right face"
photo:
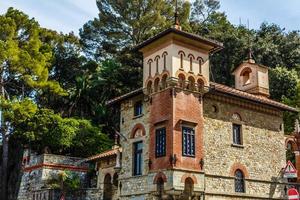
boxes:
[181,125,196,158]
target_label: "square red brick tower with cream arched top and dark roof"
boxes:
[137,28,222,198]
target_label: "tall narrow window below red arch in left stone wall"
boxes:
[133,142,143,176]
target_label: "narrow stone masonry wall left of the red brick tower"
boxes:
[119,95,150,199]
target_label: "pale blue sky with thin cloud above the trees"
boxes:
[0,0,300,35]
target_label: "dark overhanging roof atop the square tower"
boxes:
[134,28,223,50]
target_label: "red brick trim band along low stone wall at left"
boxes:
[23,163,88,172]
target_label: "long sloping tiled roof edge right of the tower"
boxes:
[210,82,298,112]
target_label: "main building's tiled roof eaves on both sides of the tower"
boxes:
[107,82,298,112]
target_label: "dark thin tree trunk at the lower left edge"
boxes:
[1,133,8,200]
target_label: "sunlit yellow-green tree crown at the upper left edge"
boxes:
[0,8,63,96]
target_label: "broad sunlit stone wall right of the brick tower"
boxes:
[204,95,285,200]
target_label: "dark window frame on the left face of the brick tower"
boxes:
[155,127,167,158]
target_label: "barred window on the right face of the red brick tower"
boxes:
[182,127,195,157]
